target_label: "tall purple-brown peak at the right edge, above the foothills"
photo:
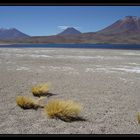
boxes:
[97,16,140,35]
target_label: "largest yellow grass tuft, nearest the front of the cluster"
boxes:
[44,99,82,121]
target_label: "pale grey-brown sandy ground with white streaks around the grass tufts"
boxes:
[0,48,140,134]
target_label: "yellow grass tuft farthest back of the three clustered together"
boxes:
[32,83,49,97]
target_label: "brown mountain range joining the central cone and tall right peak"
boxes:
[1,16,140,44]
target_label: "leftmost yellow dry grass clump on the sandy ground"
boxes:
[16,96,43,109]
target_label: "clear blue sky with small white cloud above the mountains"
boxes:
[0,6,140,36]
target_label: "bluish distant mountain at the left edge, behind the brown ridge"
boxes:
[0,28,30,40]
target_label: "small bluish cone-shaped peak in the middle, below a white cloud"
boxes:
[58,27,81,35]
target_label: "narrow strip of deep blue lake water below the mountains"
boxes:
[0,44,140,50]
